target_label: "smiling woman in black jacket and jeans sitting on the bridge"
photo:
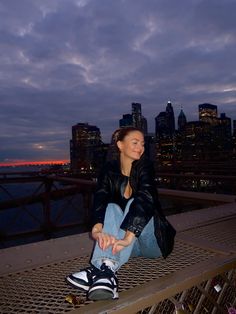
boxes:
[66,127,174,300]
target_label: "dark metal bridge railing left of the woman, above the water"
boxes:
[0,174,94,247]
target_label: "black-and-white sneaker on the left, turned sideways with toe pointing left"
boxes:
[66,266,100,291]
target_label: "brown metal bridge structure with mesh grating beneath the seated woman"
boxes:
[0,177,236,314]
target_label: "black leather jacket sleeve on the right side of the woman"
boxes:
[121,158,159,237]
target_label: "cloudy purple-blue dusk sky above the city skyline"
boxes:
[0,0,236,164]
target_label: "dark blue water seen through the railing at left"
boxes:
[0,166,86,248]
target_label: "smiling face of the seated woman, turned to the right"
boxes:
[117,131,144,161]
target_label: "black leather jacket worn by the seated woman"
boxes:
[93,156,161,237]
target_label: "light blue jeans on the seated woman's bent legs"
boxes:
[90,199,161,271]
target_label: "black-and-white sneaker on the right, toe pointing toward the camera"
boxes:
[88,264,119,301]
